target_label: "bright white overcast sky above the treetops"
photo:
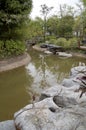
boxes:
[31,0,79,19]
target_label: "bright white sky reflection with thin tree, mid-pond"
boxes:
[27,55,57,98]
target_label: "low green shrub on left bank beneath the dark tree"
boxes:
[0,40,25,58]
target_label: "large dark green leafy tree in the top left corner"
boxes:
[0,0,32,39]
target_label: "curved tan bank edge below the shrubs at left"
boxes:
[0,53,31,72]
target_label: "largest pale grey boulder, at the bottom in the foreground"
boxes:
[14,98,86,130]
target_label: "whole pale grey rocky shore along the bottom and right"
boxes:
[0,65,86,130]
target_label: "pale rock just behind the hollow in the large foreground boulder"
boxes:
[40,85,80,101]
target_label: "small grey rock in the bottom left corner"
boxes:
[0,120,16,130]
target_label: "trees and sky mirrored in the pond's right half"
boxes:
[27,52,86,99]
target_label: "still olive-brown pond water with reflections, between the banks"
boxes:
[0,50,86,121]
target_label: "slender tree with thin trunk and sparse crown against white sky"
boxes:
[40,4,53,41]
